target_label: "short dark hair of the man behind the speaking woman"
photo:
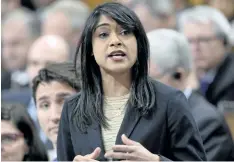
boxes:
[32,62,81,103]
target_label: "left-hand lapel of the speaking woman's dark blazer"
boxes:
[87,123,106,161]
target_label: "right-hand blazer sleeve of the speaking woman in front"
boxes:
[165,92,206,161]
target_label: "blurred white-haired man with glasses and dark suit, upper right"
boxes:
[179,6,234,109]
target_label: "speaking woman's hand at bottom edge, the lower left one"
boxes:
[73,147,101,162]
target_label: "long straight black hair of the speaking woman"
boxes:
[72,2,155,131]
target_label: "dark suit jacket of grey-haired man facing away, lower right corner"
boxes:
[189,92,234,161]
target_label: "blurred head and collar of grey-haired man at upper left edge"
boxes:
[2,8,40,89]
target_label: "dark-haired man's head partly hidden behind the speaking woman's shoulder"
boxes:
[33,63,80,160]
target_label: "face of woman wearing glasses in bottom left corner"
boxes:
[1,120,28,161]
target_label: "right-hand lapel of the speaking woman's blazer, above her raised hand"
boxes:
[115,107,141,144]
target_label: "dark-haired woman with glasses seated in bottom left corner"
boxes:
[1,103,48,161]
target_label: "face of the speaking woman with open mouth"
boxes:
[92,15,137,74]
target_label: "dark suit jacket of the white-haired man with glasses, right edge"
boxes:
[206,53,234,108]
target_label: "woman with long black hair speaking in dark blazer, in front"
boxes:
[57,2,206,161]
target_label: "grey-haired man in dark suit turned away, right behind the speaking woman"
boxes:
[147,29,234,161]
